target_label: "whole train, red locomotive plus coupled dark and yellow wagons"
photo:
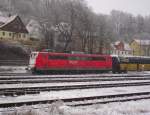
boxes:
[28,51,150,73]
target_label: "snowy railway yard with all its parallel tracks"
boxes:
[0,68,150,115]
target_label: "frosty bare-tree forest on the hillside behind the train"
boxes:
[0,0,150,53]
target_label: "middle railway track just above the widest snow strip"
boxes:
[0,82,150,96]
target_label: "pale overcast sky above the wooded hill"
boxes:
[86,0,150,16]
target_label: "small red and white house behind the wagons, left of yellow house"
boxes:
[111,41,132,55]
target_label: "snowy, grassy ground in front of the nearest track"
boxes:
[1,100,150,115]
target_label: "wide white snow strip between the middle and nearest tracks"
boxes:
[0,86,150,103]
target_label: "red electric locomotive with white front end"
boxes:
[29,51,112,73]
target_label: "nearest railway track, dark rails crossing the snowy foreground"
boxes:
[0,92,150,108]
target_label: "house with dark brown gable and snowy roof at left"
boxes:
[0,15,28,41]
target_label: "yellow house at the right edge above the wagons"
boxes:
[130,39,150,56]
